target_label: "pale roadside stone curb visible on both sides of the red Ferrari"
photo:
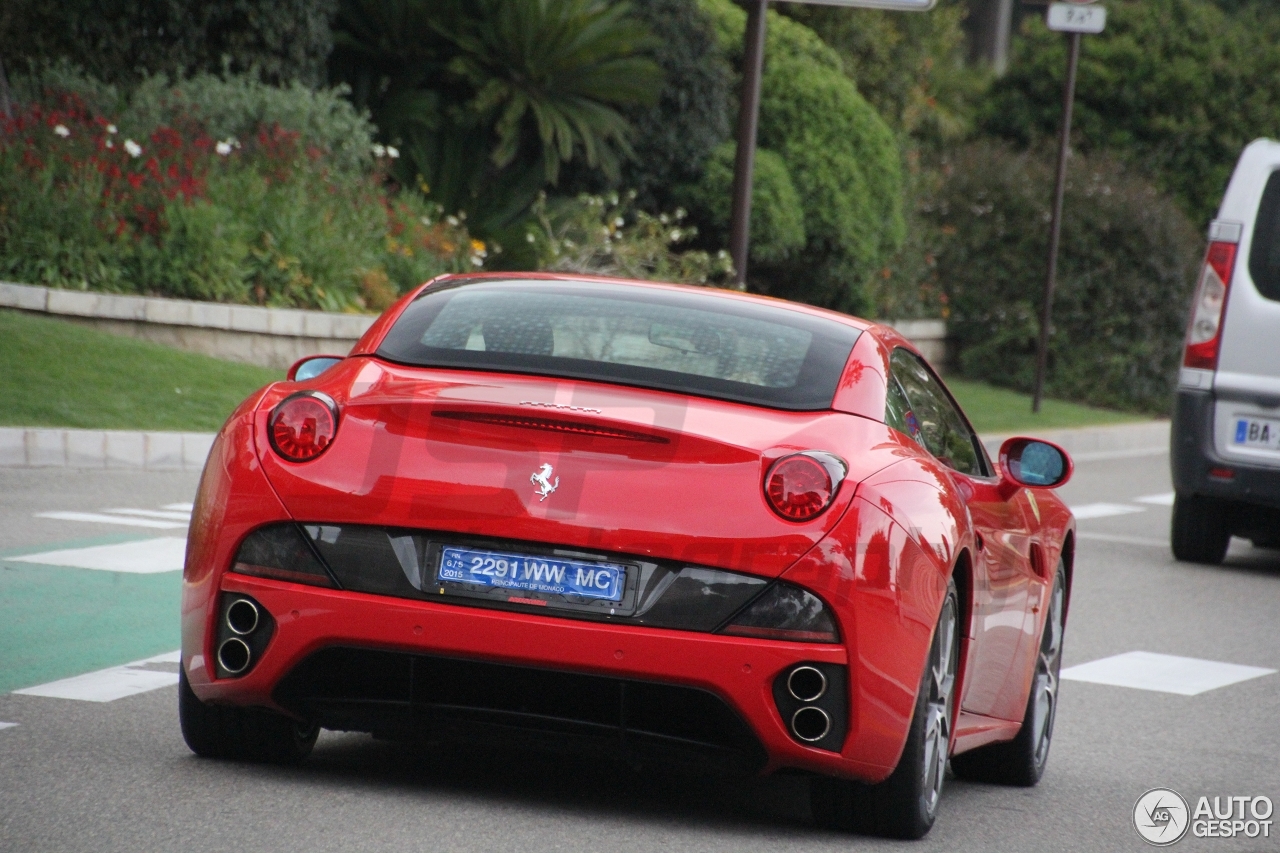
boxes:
[0,420,1169,471]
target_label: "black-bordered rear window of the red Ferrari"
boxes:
[378,280,859,411]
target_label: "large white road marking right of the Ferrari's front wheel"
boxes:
[1061,652,1275,695]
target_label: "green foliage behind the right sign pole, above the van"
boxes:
[983,0,1280,222]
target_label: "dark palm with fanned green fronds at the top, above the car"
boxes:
[330,0,662,233]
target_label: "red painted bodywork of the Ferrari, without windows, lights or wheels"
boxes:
[182,274,1074,814]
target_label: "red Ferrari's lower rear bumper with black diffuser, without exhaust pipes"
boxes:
[183,574,900,781]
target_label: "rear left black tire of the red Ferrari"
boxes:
[178,669,320,765]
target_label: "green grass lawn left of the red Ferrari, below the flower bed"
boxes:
[0,310,284,433]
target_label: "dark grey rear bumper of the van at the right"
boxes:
[1169,391,1280,508]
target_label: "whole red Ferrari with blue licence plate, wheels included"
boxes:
[179,274,1075,838]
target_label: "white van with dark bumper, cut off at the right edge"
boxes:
[1170,140,1280,564]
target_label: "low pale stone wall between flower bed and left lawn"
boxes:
[0,282,378,341]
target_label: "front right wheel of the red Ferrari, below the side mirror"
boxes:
[951,561,1066,788]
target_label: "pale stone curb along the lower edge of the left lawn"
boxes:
[0,427,214,471]
